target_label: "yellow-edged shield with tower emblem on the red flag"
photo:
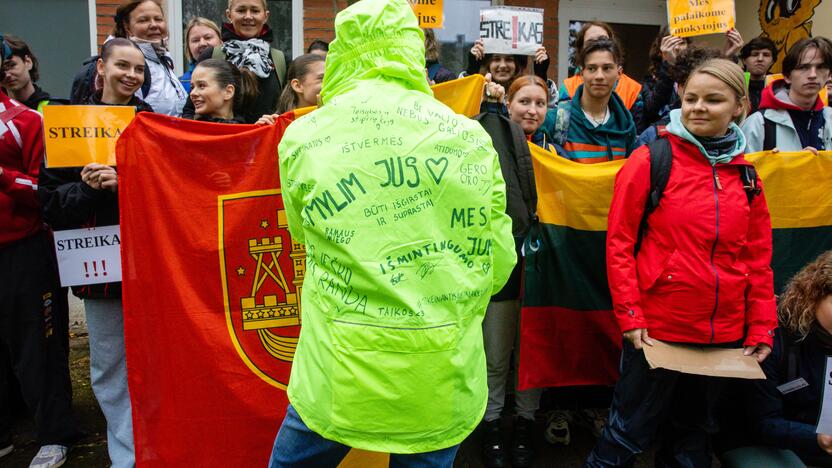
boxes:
[218,189,306,390]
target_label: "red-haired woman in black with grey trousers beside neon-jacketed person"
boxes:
[475,75,550,468]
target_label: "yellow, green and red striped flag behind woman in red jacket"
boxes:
[519,145,832,389]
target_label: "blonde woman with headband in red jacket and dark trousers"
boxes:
[586,59,777,467]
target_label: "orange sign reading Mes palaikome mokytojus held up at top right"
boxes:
[667,0,736,37]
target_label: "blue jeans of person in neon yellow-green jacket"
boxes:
[269,405,459,468]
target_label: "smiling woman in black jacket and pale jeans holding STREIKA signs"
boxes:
[38,38,153,467]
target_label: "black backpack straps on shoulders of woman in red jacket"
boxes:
[635,136,761,252]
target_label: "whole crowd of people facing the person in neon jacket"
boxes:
[0,0,832,467]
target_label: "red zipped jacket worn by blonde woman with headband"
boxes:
[607,135,777,346]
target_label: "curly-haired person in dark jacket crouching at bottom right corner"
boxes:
[722,250,832,466]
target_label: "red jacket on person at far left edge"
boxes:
[0,91,43,247]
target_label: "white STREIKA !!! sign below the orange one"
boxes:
[54,225,121,287]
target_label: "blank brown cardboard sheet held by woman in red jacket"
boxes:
[642,338,766,379]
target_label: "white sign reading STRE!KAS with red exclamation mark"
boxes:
[480,7,543,55]
